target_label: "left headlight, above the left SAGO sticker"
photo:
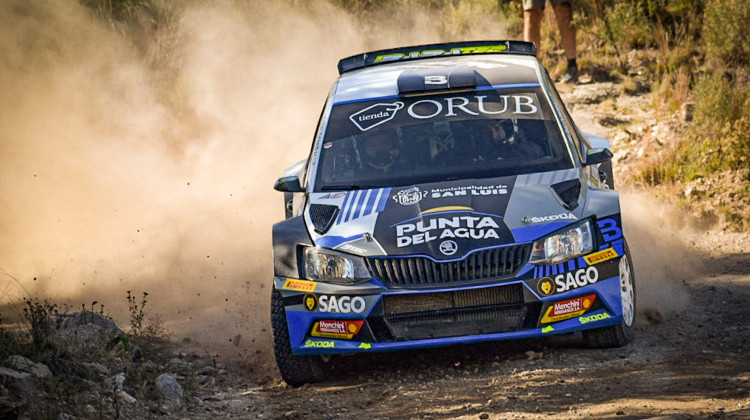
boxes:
[304,247,372,284]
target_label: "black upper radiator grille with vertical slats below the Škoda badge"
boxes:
[367,244,531,288]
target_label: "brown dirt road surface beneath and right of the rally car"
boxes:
[179,210,750,419]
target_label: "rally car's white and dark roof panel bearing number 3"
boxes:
[333,53,541,104]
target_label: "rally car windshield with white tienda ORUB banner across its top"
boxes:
[315,88,573,191]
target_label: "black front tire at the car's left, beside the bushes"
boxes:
[271,289,328,386]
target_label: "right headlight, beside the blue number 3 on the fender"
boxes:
[529,220,594,264]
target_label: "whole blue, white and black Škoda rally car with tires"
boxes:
[271,41,635,385]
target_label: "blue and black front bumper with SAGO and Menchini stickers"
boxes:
[274,241,624,355]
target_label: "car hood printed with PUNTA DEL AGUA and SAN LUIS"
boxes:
[305,169,585,260]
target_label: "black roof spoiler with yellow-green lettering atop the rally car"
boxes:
[339,41,536,74]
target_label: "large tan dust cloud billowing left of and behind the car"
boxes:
[0,0,503,364]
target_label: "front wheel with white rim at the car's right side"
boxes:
[583,243,636,349]
